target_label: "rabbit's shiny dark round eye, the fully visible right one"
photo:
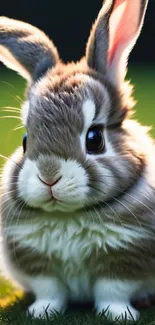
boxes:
[86,127,105,154]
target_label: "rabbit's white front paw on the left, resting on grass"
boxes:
[28,299,65,318]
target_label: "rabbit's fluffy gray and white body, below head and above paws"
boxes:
[2,120,155,316]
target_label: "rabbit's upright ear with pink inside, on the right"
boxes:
[86,0,148,87]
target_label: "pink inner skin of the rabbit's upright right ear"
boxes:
[108,0,141,65]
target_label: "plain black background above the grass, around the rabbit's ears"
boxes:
[0,0,155,64]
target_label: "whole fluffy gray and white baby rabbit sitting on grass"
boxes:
[0,0,155,319]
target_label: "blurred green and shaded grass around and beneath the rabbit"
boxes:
[0,65,155,325]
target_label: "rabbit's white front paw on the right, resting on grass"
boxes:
[97,302,139,320]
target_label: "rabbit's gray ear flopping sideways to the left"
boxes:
[0,17,59,81]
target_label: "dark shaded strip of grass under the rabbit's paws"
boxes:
[0,293,155,325]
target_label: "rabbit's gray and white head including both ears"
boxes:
[0,0,148,212]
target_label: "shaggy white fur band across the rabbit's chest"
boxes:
[6,211,145,266]
